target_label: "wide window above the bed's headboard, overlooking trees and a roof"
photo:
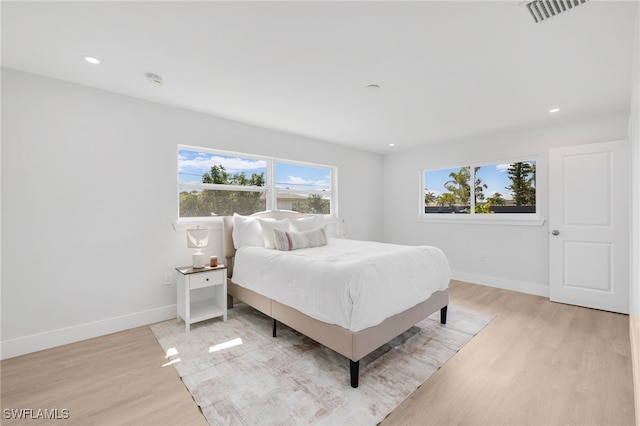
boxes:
[178,146,336,218]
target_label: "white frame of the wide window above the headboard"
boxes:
[176,144,338,224]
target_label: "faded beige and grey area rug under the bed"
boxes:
[151,304,493,425]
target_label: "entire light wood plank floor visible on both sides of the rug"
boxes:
[0,282,635,426]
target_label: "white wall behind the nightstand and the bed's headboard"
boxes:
[1,69,383,358]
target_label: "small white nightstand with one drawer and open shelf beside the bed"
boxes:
[176,265,227,331]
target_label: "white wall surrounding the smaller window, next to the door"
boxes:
[384,113,629,296]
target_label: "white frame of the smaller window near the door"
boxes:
[417,155,545,226]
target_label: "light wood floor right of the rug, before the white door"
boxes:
[383,282,635,426]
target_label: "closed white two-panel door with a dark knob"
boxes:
[549,141,630,313]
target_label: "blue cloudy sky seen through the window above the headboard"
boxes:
[178,149,331,190]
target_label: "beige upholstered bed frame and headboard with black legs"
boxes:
[222,210,449,388]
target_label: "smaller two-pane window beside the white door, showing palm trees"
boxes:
[421,160,536,216]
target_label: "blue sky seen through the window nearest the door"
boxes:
[425,163,536,200]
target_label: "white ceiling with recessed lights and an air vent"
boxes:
[2,0,637,153]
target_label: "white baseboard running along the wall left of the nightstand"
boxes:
[0,305,176,359]
